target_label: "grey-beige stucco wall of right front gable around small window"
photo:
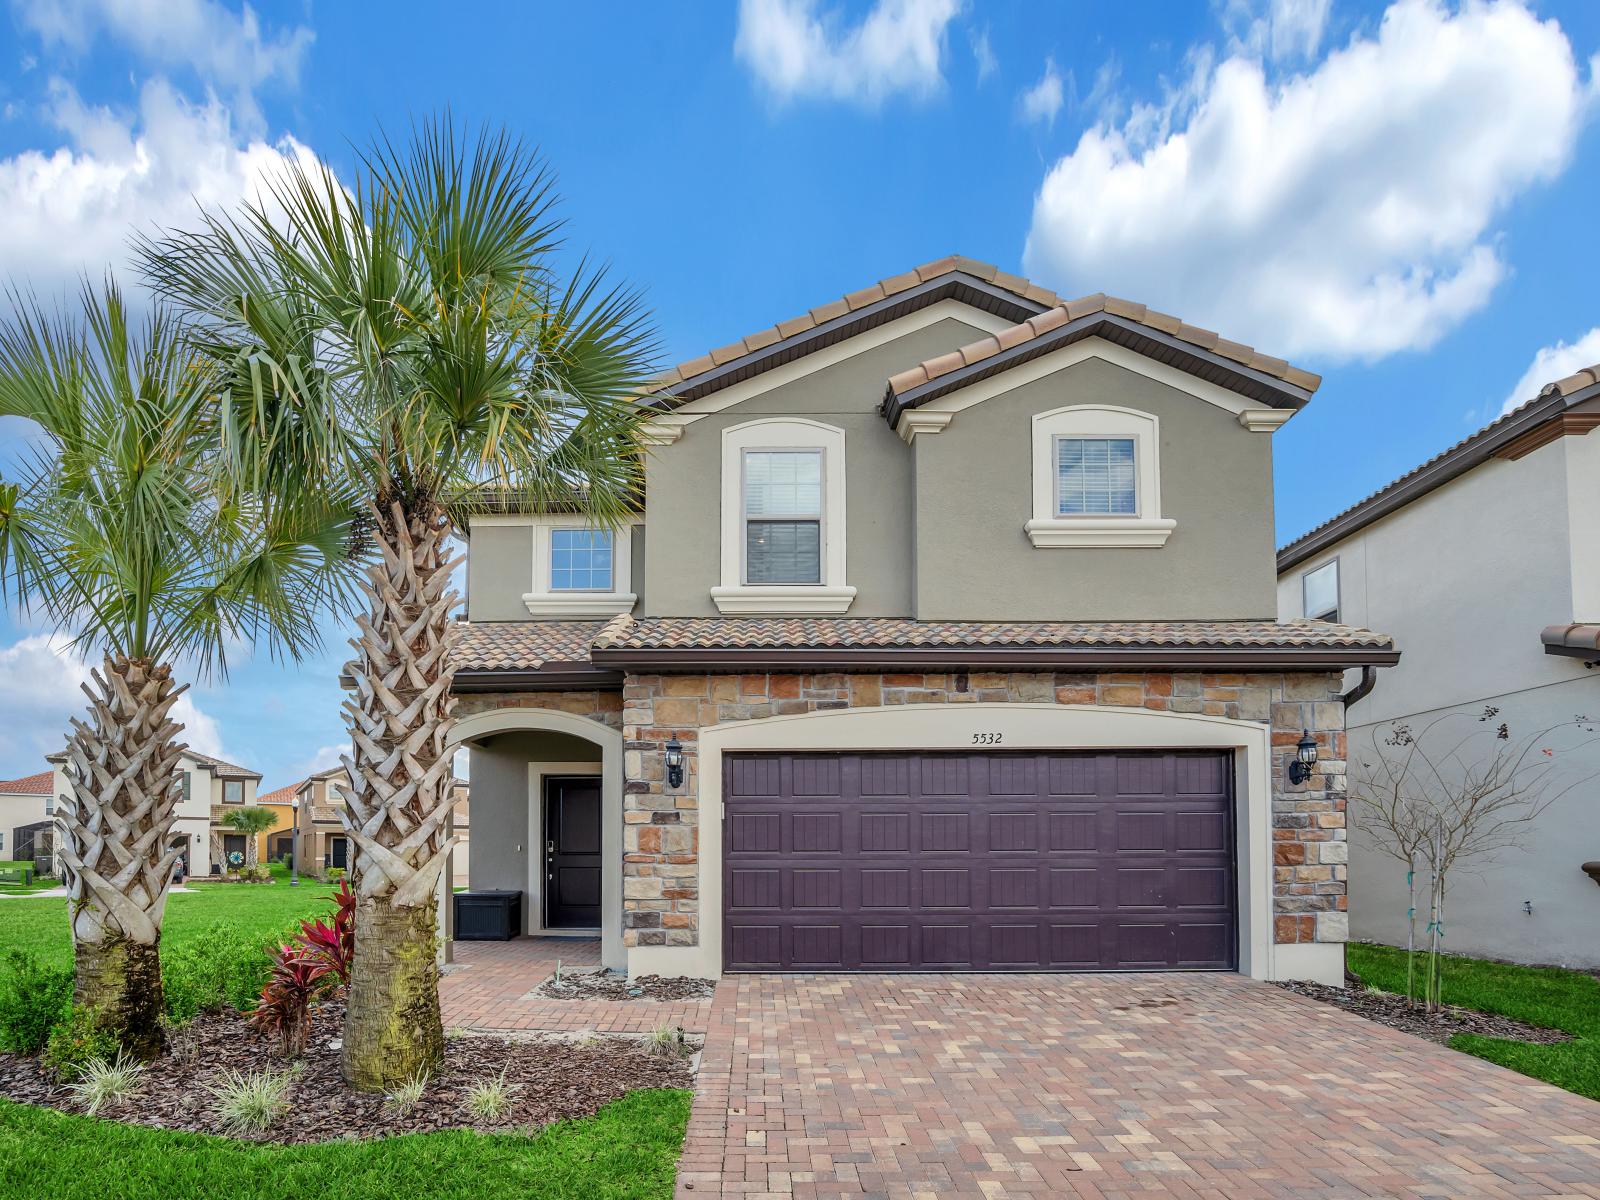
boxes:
[914,358,1277,621]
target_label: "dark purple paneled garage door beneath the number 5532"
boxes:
[723,752,1238,971]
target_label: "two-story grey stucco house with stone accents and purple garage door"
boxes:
[454,258,1398,982]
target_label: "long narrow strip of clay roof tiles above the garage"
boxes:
[594,618,1394,650]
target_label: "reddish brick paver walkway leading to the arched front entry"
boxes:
[438,938,710,1034]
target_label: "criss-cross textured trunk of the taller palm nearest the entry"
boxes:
[341,502,458,1091]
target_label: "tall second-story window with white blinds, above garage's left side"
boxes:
[744,450,822,584]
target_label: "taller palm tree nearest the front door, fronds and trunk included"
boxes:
[141,118,654,1090]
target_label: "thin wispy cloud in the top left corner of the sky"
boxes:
[16,0,315,128]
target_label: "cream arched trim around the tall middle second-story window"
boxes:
[710,416,856,616]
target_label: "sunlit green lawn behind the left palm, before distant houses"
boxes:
[0,880,333,966]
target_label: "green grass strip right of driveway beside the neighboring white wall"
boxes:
[1349,942,1600,1099]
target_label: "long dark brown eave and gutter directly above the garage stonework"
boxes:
[594,646,1400,672]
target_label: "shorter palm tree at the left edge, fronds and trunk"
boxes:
[0,283,349,1058]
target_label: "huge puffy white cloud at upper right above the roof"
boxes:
[1026,0,1594,360]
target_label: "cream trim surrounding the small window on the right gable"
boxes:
[1022,405,1178,550]
